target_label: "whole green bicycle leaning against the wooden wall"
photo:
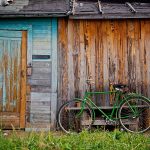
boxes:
[57,80,150,133]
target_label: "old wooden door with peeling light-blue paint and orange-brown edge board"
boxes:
[0,30,27,129]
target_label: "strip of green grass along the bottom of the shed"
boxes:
[0,130,150,150]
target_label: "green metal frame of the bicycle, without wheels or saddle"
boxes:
[76,91,124,121]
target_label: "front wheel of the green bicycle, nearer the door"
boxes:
[57,100,92,133]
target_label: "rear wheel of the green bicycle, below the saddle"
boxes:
[118,97,150,133]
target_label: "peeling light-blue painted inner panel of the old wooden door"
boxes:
[0,30,21,112]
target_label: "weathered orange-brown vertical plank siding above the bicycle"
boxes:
[58,19,150,105]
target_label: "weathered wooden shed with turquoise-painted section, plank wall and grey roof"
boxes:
[0,0,150,130]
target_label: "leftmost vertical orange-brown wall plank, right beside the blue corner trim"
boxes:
[58,18,69,104]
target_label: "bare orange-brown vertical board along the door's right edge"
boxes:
[20,31,27,128]
